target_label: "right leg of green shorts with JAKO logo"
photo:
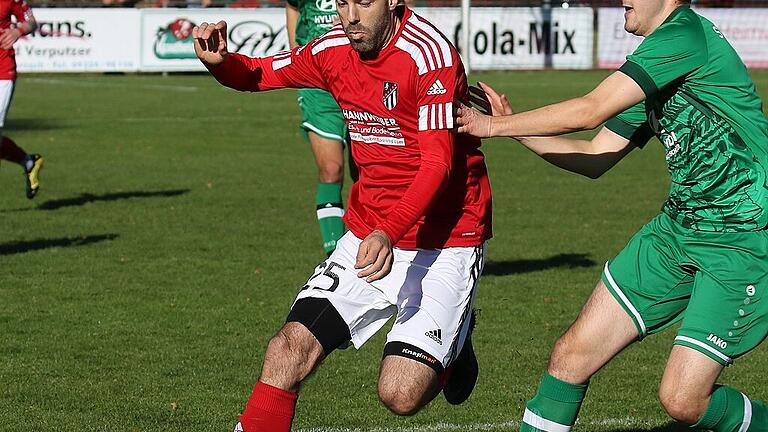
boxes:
[675,231,768,366]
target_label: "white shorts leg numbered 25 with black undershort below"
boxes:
[288,232,397,354]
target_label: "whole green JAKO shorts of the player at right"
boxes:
[602,213,768,366]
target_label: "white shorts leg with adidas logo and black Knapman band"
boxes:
[384,245,485,374]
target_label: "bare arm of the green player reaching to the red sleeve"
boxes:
[456,72,645,138]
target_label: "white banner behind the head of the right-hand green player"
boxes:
[597,8,768,68]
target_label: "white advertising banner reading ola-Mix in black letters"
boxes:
[417,7,594,70]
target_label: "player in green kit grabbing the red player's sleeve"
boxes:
[456,0,768,432]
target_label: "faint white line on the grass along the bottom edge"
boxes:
[296,417,658,432]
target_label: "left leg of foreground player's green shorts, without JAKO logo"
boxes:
[602,214,693,339]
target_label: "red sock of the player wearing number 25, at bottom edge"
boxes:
[240,381,299,432]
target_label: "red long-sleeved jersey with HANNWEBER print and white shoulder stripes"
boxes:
[211,9,491,249]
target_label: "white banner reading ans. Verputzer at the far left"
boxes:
[15,8,141,72]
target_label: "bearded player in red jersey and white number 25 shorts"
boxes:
[193,0,491,432]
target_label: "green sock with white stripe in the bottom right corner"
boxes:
[691,385,768,432]
